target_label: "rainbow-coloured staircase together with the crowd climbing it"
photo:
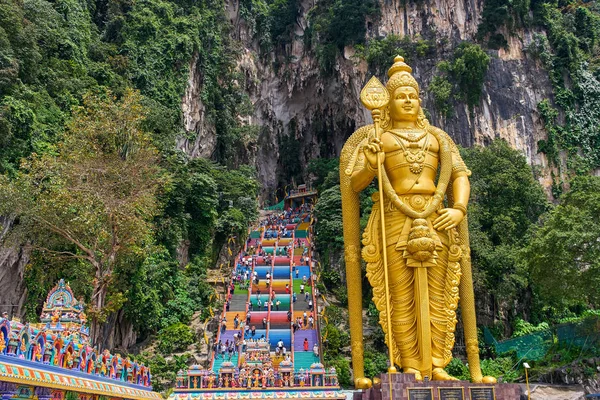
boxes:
[212,204,321,382]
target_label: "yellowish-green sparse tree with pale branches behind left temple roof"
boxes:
[0,91,168,340]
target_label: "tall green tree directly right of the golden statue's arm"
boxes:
[462,140,548,326]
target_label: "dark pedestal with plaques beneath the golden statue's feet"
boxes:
[354,374,521,400]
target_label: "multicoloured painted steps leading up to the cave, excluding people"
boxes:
[212,206,321,372]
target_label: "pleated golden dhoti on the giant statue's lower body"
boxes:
[362,195,460,377]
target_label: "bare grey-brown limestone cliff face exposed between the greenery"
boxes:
[179,0,551,198]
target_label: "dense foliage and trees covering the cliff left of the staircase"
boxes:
[0,0,259,356]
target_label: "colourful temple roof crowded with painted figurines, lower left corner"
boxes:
[0,279,161,400]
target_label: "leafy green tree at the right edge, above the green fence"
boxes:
[524,176,600,309]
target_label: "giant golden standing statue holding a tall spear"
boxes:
[340,56,495,388]
